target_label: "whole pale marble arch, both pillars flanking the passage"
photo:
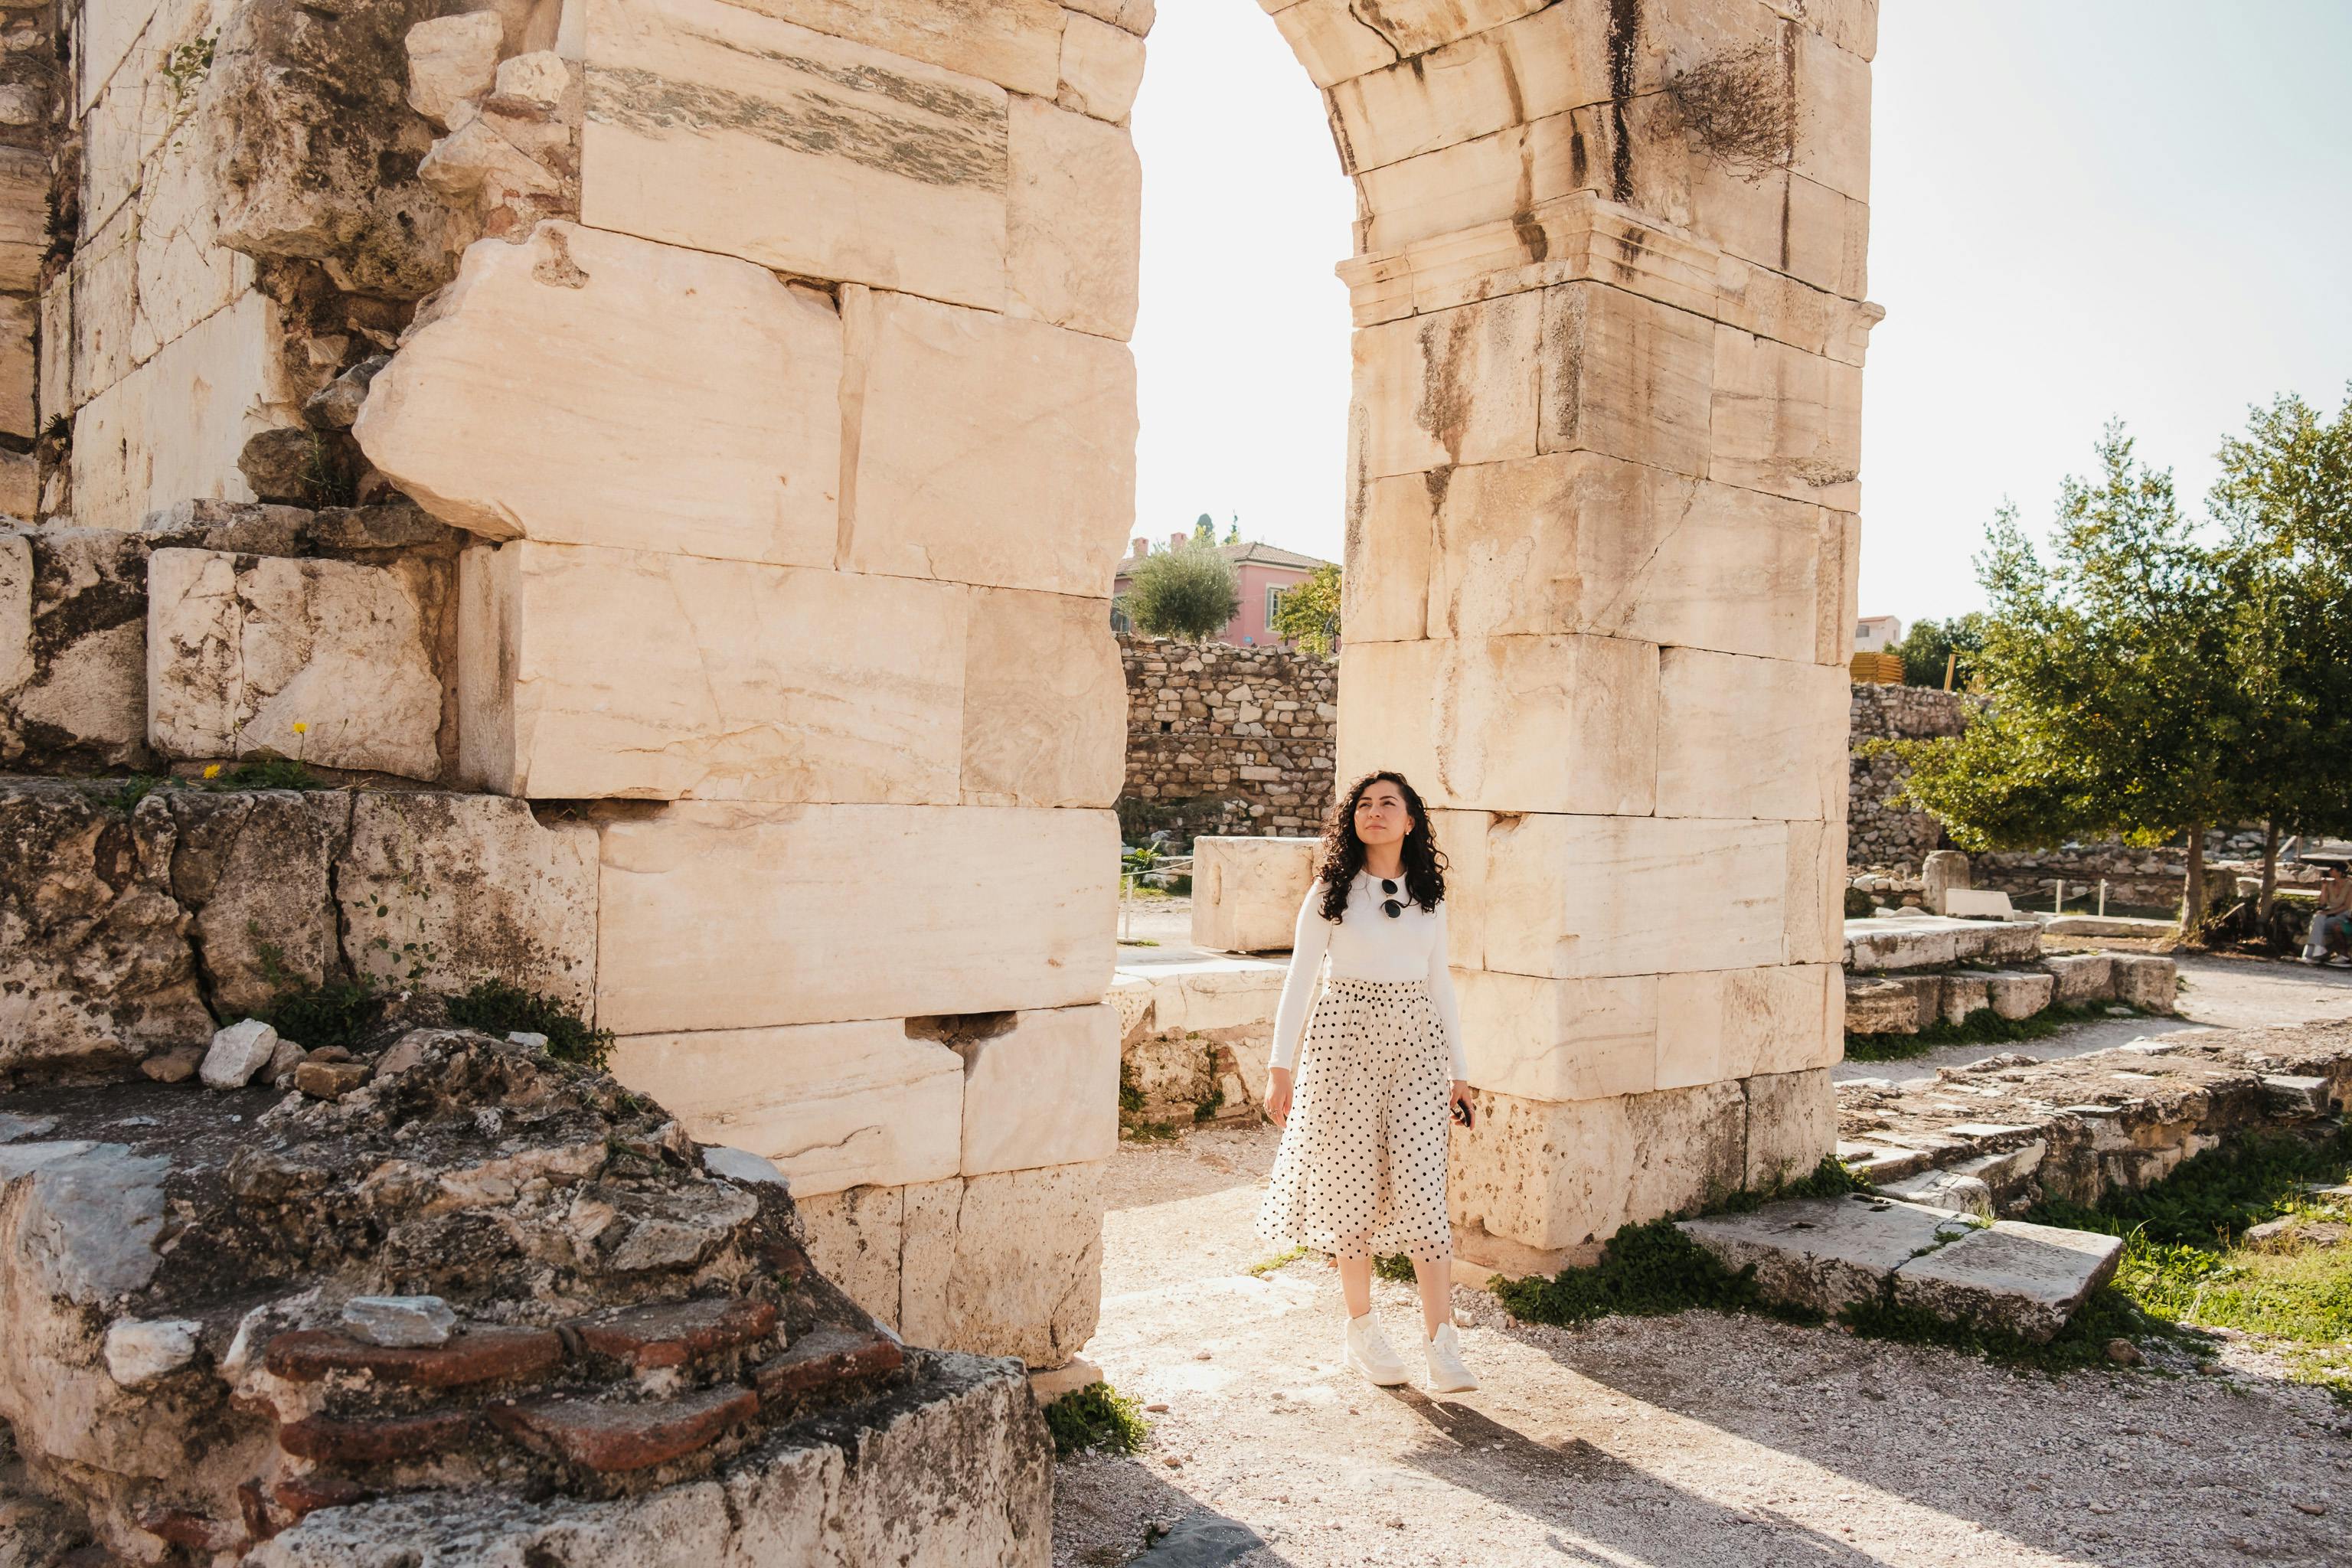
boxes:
[341,0,1874,1335]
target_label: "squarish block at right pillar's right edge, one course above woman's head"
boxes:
[1658,648,1851,823]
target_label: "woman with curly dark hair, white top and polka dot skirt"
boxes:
[1259,773,1477,1394]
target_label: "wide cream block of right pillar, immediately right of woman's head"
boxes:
[1446,813,1788,980]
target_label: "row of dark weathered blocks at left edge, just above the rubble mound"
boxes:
[0,780,595,1083]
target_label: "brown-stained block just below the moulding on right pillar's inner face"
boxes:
[1350,294,1545,479]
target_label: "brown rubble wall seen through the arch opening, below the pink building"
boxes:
[1119,637,1338,844]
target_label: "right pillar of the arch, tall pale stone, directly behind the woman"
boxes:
[1270,0,1880,1272]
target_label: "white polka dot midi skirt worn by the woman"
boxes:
[1259,975,1453,1263]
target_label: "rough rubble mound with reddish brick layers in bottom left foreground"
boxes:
[0,1030,1049,1563]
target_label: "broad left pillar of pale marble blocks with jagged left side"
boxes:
[358,0,1150,1366]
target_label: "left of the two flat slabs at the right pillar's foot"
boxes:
[1679,1197,1971,1312]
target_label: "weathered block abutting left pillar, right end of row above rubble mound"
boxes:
[334,790,597,1021]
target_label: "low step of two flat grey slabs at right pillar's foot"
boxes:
[1681,1194,2124,1342]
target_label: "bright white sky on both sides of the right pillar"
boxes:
[1134,0,2352,621]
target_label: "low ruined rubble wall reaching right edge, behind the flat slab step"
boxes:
[1837,1023,2352,1213]
